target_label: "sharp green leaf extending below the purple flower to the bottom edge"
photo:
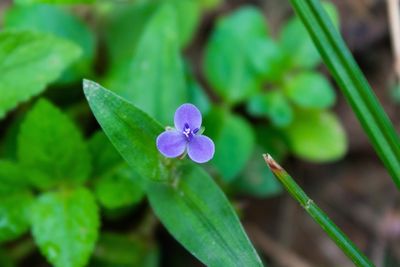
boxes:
[148,168,262,267]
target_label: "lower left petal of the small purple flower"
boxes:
[157,130,187,158]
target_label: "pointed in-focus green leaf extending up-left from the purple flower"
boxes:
[83,80,167,183]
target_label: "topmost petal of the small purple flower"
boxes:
[174,103,202,131]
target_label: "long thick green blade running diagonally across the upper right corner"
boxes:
[290,0,400,190]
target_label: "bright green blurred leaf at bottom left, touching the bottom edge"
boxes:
[32,188,100,267]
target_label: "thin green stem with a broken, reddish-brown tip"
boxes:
[263,154,374,267]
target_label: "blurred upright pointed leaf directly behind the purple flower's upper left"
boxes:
[109,5,187,125]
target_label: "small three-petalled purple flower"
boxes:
[157,104,215,163]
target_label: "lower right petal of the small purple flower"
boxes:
[188,135,215,163]
